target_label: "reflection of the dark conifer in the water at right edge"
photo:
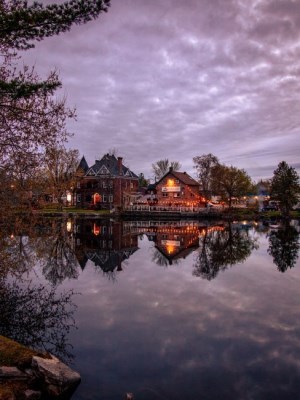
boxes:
[268,223,300,272]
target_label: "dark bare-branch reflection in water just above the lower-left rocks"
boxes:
[0,280,76,361]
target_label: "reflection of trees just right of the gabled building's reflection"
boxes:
[193,223,257,280]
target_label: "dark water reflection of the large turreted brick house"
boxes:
[74,219,138,272]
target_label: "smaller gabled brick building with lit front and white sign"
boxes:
[155,168,204,206]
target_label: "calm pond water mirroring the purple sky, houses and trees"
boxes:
[0,219,300,400]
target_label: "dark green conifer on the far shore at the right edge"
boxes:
[270,161,300,217]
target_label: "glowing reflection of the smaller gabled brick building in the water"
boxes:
[154,225,199,264]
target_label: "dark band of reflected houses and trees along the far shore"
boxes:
[0,218,299,286]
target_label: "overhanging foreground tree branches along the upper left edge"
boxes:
[0,0,110,192]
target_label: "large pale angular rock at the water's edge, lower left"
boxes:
[32,356,81,396]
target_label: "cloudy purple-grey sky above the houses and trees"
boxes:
[23,0,300,180]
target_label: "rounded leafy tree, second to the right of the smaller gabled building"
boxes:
[212,164,253,207]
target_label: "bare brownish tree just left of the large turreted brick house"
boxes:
[44,146,79,208]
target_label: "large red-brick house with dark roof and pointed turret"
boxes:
[74,154,138,209]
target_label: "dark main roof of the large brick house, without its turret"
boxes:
[85,154,138,179]
